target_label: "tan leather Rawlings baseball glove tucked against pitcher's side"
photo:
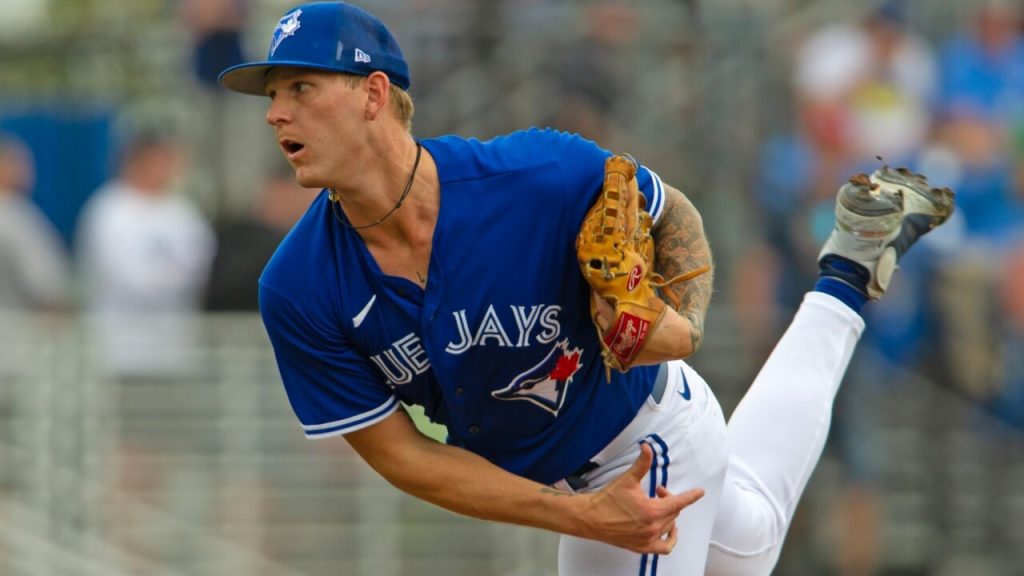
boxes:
[577,156,710,380]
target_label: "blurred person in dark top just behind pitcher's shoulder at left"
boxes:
[206,162,318,312]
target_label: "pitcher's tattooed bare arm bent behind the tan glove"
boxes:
[651,186,714,352]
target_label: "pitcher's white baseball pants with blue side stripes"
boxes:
[558,292,864,576]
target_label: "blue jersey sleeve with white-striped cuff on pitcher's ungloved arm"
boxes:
[260,283,398,438]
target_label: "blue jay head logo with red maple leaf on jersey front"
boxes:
[490,338,583,416]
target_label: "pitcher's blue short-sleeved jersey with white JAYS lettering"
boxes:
[260,129,665,484]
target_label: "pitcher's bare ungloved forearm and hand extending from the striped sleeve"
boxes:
[346,412,703,553]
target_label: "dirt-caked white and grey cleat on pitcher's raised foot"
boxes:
[818,166,953,300]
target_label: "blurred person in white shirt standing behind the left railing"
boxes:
[76,116,216,574]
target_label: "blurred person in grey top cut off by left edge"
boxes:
[0,134,71,311]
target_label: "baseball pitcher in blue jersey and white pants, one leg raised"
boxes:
[220,2,952,576]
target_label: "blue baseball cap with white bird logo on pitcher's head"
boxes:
[217,2,410,96]
